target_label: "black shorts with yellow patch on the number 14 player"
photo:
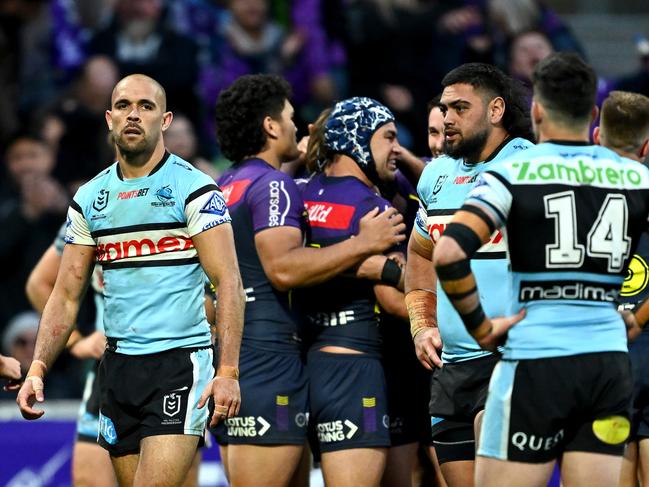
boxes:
[478,352,633,463]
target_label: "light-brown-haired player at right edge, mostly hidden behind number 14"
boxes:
[593,91,649,487]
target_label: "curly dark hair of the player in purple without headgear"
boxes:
[216,74,291,163]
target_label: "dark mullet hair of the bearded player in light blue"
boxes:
[442,63,534,140]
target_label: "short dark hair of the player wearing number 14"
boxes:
[532,52,597,124]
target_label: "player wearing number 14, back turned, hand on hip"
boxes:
[433,53,649,487]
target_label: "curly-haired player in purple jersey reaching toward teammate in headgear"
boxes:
[216,75,405,486]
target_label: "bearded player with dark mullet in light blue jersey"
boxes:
[406,64,532,487]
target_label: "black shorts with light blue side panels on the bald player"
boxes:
[98,346,214,456]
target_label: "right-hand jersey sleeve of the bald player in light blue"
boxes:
[185,179,232,237]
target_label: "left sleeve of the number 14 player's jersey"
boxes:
[465,171,512,228]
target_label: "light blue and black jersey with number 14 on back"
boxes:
[467,142,649,360]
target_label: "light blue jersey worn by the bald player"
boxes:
[65,153,230,355]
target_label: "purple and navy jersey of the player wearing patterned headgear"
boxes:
[296,174,392,354]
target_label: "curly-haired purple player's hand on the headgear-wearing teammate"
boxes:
[356,208,406,254]
